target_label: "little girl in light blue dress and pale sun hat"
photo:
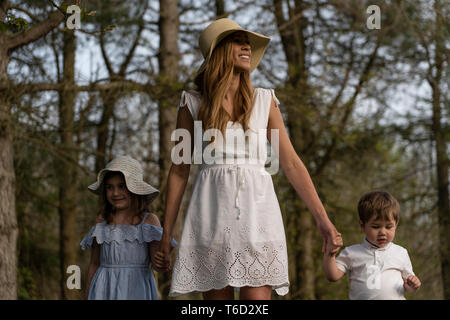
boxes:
[80,156,175,300]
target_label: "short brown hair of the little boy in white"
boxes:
[358,191,400,224]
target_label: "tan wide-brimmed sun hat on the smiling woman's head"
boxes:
[198,18,270,72]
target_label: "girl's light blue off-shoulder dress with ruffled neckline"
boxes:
[80,213,176,300]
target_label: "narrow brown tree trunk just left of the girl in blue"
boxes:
[58,30,78,299]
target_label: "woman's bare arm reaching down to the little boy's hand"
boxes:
[267,98,342,252]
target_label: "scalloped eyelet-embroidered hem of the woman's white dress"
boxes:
[169,242,289,296]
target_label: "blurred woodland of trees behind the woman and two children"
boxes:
[0,0,450,299]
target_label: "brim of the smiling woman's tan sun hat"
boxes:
[204,28,270,73]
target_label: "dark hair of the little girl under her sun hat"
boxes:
[98,171,150,224]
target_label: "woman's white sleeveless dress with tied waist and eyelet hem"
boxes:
[169,88,289,296]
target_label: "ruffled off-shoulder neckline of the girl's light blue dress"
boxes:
[80,221,178,250]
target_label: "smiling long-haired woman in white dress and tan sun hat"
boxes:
[155,19,342,300]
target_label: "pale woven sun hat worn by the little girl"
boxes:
[88,156,159,202]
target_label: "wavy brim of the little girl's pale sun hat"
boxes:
[88,169,160,202]
